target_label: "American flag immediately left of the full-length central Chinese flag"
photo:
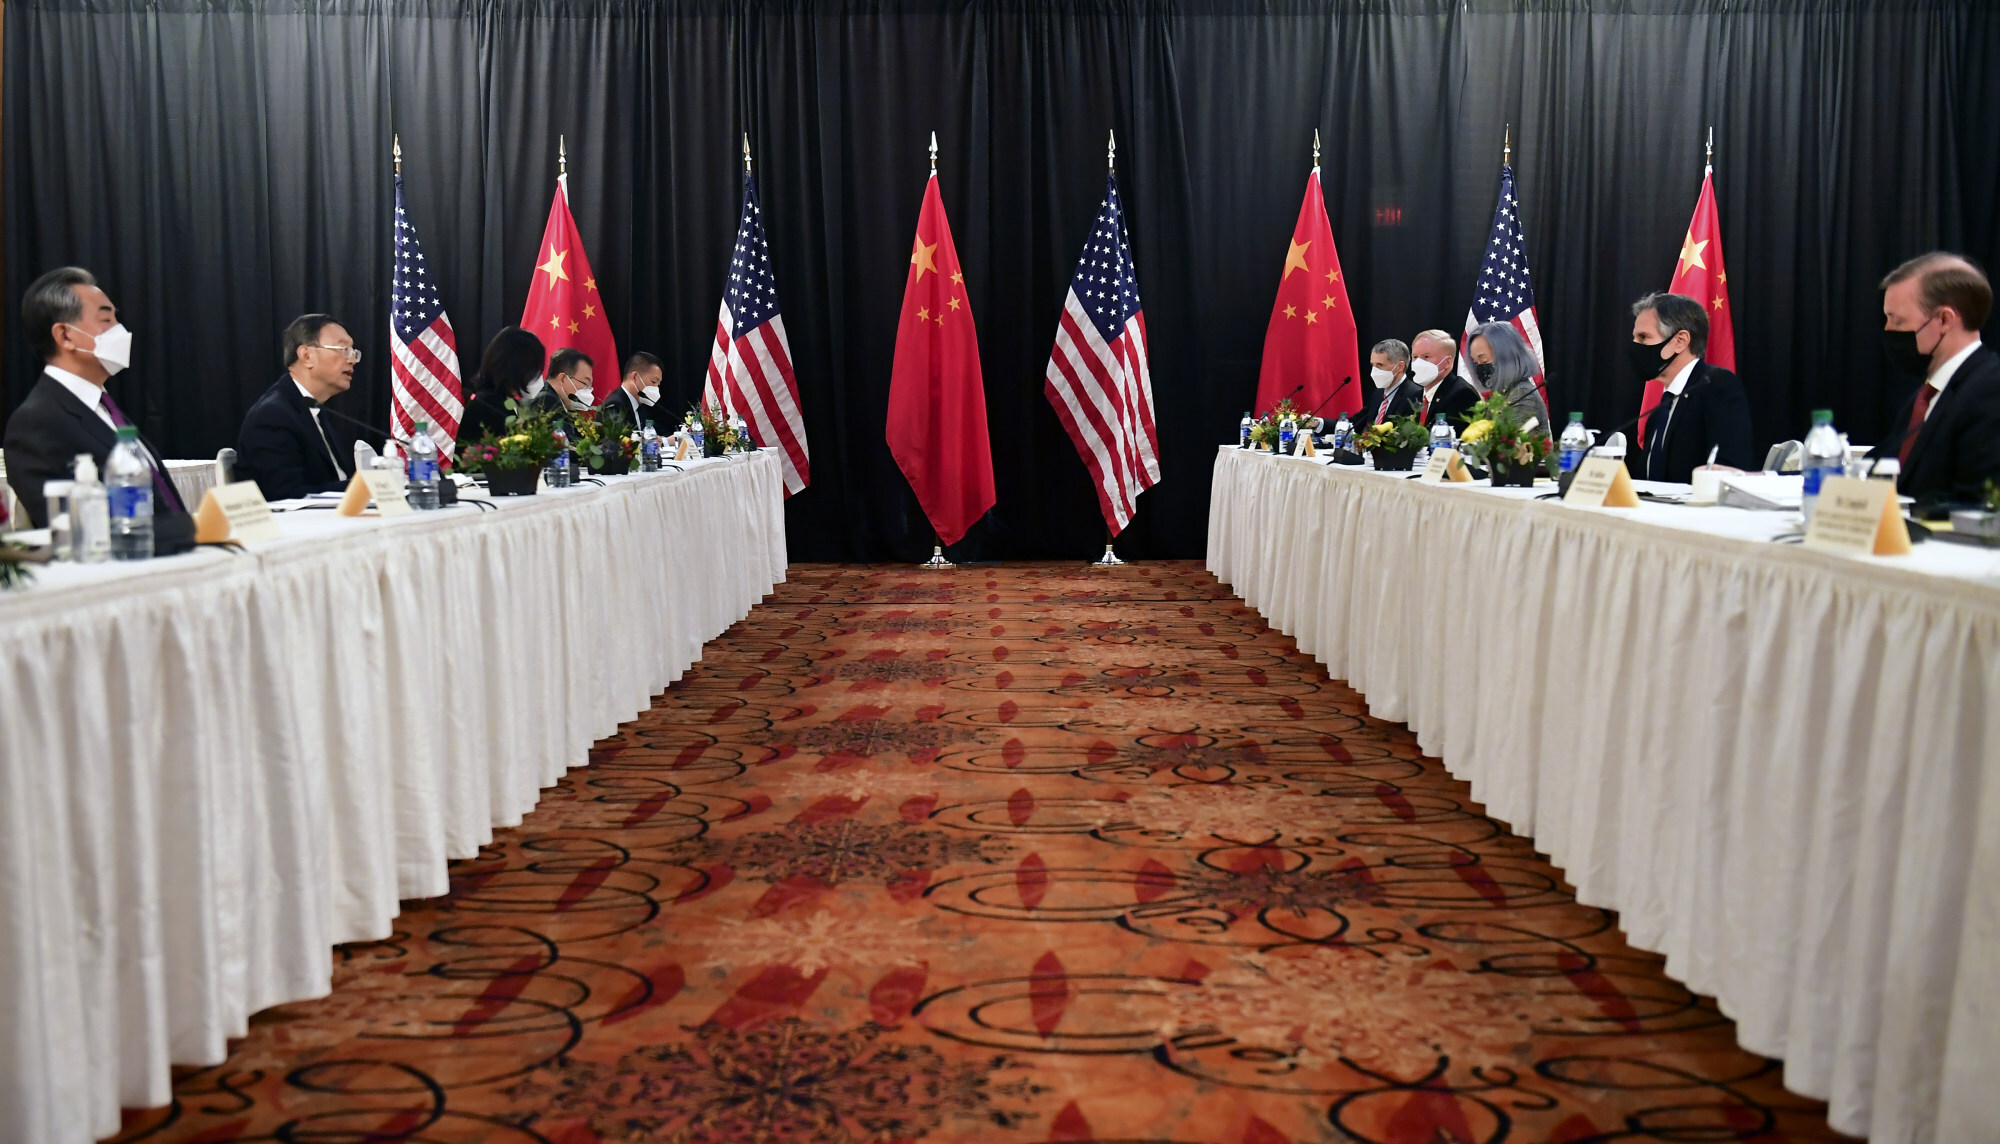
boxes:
[702,172,812,496]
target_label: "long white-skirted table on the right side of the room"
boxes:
[1208,448,2000,1144]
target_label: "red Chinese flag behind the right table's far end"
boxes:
[1256,168,1362,414]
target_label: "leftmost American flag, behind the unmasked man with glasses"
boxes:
[388,174,466,456]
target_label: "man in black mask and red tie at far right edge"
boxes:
[1878,254,2000,504]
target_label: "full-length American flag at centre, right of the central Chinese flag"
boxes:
[1042,176,1160,536]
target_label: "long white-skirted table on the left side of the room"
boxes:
[0,452,786,1144]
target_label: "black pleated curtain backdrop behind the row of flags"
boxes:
[0,0,2000,560]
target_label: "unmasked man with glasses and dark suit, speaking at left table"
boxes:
[236,314,362,500]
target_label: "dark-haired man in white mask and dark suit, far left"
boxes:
[0,266,186,528]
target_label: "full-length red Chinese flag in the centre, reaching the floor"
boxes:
[888,172,994,544]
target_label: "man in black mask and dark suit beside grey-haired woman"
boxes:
[1624,294,1762,484]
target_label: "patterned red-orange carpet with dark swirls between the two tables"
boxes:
[105,564,1836,1144]
